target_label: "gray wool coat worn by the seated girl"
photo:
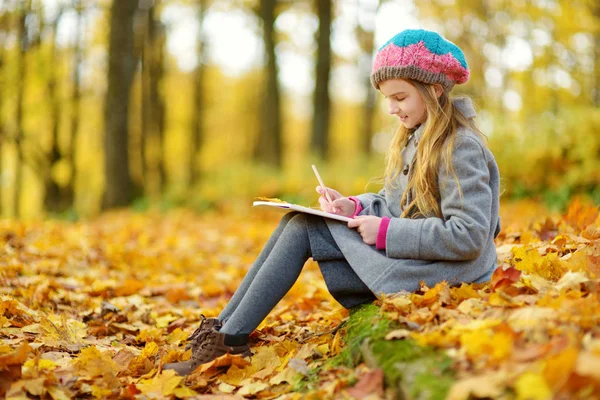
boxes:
[325,97,500,297]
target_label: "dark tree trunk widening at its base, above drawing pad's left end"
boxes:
[254,0,281,168]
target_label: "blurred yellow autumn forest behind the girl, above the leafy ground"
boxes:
[0,0,600,218]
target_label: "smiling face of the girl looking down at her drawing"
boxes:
[379,79,427,129]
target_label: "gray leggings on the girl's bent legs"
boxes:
[218,212,376,335]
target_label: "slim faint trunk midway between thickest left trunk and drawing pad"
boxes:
[188,0,207,187]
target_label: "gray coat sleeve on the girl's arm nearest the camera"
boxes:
[386,135,495,261]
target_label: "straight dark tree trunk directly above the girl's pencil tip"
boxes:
[312,0,331,159]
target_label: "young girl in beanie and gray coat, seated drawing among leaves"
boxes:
[164,30,500,374]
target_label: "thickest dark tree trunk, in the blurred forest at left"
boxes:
[102,0,138,209]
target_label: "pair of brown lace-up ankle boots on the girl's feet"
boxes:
[163,329,252,375]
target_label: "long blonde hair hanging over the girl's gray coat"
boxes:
[377,80,487,218]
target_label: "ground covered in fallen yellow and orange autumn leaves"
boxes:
[0,201,600,399]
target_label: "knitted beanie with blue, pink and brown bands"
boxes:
[371,29,469,91]
